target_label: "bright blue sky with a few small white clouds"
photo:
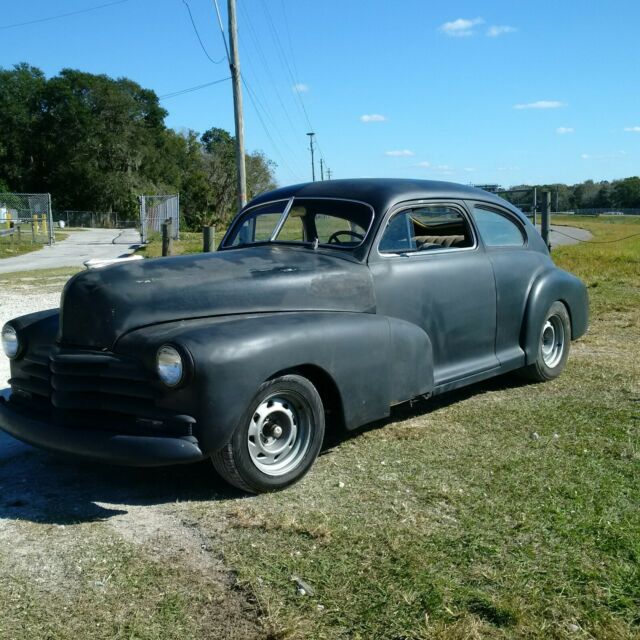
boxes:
[0,0,640,186]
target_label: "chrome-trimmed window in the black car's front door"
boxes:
[378,205,473,253]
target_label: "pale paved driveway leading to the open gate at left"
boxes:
[0,229,140,273]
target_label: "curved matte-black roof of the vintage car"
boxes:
[249,178,522,217]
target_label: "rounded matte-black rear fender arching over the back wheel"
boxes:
[521,268,589,364]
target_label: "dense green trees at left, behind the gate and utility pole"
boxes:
[0,63,276,228]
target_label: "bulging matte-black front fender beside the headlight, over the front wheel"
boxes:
[116,312,432,453]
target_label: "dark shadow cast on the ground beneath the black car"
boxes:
[0,376,526,525]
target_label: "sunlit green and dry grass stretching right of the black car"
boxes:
[188,218,640,639]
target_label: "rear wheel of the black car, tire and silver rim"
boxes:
[518,302,571,382]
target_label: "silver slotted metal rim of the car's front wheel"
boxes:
[247,392,313,476]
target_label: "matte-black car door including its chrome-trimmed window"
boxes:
[369,202,499,386]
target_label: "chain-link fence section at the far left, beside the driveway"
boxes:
[0,192,55,244]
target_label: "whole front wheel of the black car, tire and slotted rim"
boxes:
[212,375,324,493]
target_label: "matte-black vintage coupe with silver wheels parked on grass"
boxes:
[0,180,588,492]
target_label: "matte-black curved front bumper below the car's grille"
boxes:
[0,397,206,467]
